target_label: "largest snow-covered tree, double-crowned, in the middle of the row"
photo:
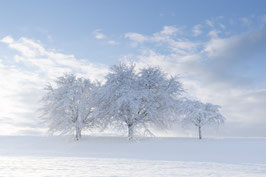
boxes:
[95,63,182,140]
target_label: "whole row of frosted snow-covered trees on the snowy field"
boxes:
[41,63,224,140]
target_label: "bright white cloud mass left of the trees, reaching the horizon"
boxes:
[0,36,108,134]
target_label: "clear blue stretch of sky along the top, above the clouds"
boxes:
[0,0,266,64]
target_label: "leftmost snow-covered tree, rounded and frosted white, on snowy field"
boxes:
[41,74,95,140]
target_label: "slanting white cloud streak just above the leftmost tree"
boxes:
[2,37,106,78]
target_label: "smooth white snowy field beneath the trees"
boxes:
[0,136,266,177]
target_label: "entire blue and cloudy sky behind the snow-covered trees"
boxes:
[0,0,266,137]
